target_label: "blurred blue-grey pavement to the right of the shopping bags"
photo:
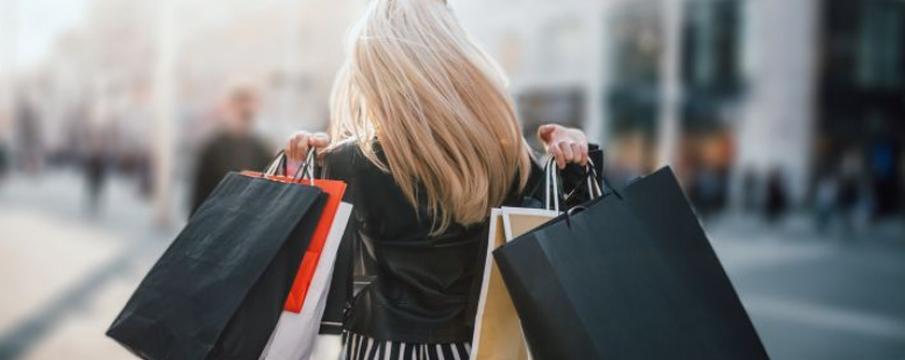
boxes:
[708,215,905,360]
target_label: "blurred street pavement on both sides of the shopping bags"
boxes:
[0,172,905,360]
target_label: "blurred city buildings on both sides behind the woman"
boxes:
[0,0,905,219]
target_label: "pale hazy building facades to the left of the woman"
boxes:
[0,0,366,224]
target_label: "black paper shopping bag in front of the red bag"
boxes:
[107,173,326,360]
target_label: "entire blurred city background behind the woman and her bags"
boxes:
[0,0,905,360]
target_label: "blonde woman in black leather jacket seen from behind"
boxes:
[286,0,588,360]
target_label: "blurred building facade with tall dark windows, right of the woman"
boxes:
[457,0,905,214]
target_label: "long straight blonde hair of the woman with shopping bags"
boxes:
[331,0,531,235]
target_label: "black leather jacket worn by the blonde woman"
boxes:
[323,143,602,344]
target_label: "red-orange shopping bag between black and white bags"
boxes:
[243,172,346,313]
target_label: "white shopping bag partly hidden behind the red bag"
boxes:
[260,203,352,360]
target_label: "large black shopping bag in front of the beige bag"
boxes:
[494,168,768,360]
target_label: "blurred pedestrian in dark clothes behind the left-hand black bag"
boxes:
[190,84,273,214]
